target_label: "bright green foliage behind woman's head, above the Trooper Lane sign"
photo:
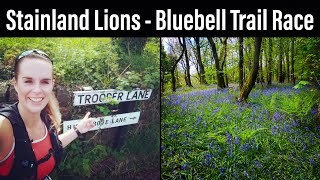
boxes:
[0,38,160,89]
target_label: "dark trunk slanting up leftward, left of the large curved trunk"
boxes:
[207,37,226,89]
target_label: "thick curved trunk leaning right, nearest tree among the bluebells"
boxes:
[238,37,262,101]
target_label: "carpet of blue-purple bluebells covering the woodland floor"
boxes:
[161,87,320,179]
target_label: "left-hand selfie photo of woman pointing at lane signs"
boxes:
[0,37,160,180]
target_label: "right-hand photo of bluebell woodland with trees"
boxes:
[160,37,320,180]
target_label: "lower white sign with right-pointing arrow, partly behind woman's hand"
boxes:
[63,111,140,132]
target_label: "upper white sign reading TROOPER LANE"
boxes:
[73,89,152,106]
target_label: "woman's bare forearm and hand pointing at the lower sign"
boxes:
[59,112,94,147]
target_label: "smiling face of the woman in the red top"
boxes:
[14,57,53,113]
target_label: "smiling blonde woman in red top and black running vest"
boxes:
[0,49,94,179]
